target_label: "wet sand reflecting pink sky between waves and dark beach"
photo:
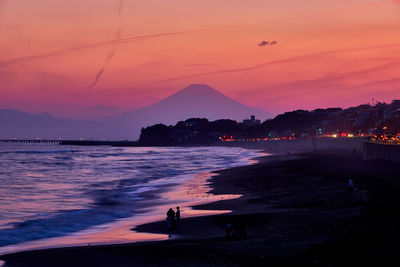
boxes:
[0,149,265,260]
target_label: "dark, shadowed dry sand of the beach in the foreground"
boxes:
[0,151,400,266]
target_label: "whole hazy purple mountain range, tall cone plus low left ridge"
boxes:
[0,84,270,140]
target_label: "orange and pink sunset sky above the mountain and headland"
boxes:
[0,0,400,118]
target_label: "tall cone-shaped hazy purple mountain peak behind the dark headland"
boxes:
[112,84,271,138]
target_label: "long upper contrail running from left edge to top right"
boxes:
[0,0,390,67]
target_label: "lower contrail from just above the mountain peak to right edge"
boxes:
[155,43,400,83]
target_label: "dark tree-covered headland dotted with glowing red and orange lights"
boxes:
[139,100,400,146]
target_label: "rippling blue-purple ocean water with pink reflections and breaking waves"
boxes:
[0,144,260,252]
